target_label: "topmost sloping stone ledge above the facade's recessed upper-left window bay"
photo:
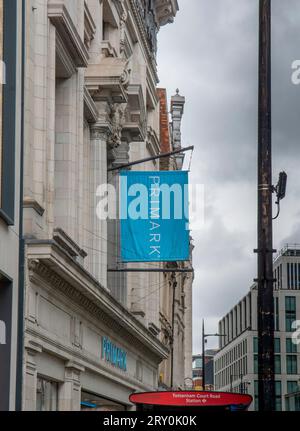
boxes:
[48,0,88,67]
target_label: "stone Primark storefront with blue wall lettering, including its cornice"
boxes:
[24,241,168,411]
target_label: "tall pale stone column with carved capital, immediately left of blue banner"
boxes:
[89,123,110,287]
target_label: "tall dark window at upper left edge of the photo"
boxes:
[0,0,17,225]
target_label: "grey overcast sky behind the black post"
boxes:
[158,0,300,353]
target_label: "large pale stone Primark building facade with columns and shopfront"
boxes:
[23,0,192,410]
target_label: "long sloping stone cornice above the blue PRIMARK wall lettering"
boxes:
[26,240,168,360]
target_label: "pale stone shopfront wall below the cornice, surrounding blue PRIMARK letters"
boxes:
[24,276,157,411]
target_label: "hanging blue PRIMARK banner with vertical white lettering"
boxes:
[120,171,189,262]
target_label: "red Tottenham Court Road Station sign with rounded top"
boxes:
[130,391,252,409]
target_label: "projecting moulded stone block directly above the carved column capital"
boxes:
[85,57,130,103]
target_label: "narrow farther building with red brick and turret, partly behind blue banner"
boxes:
[157,88,194,389]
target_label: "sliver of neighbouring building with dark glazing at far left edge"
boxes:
[0,0,22,411]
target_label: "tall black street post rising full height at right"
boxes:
[256,0,275,411]
